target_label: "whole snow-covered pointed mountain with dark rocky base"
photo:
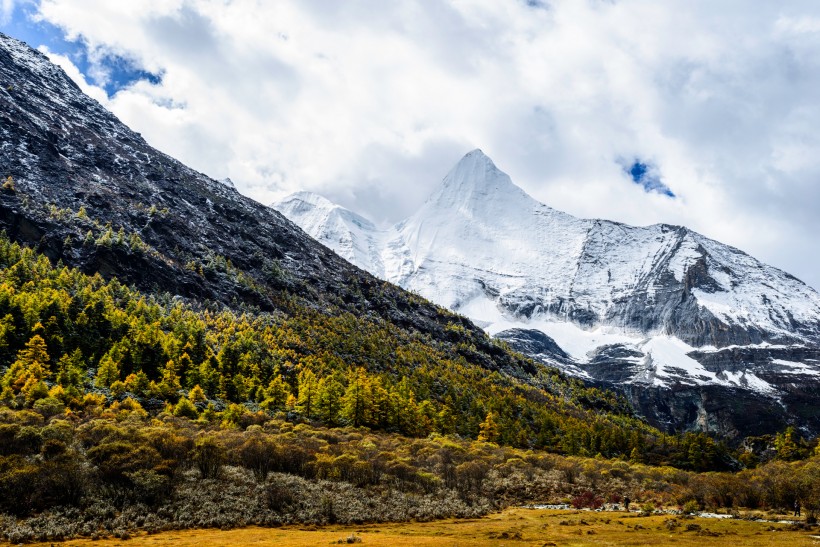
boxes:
[274,150,820,435]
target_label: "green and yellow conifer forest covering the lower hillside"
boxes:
[0,233,732,470]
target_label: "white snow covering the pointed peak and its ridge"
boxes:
[276,150,820,393]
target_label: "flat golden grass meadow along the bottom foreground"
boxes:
[11,508,820,547]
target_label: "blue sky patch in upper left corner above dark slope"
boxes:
[1,3,162,97]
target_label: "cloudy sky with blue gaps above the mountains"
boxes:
[0,0,820,288]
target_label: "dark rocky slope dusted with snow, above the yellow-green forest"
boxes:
[0,34,532,377]
